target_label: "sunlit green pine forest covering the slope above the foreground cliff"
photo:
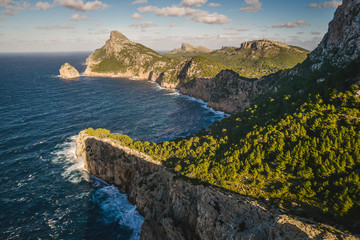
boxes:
[87,60,360,231]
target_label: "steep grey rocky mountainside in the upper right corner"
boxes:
[310,0,360,66]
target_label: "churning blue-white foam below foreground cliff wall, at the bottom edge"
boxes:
[93,183,144,239]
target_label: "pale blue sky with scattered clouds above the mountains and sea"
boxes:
[0,0,342,52]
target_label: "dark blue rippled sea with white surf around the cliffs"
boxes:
[0,53,224,239]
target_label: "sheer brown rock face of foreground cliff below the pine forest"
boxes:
[76,131,358,240]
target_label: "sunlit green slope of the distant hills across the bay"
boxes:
[165,40,309,78]
